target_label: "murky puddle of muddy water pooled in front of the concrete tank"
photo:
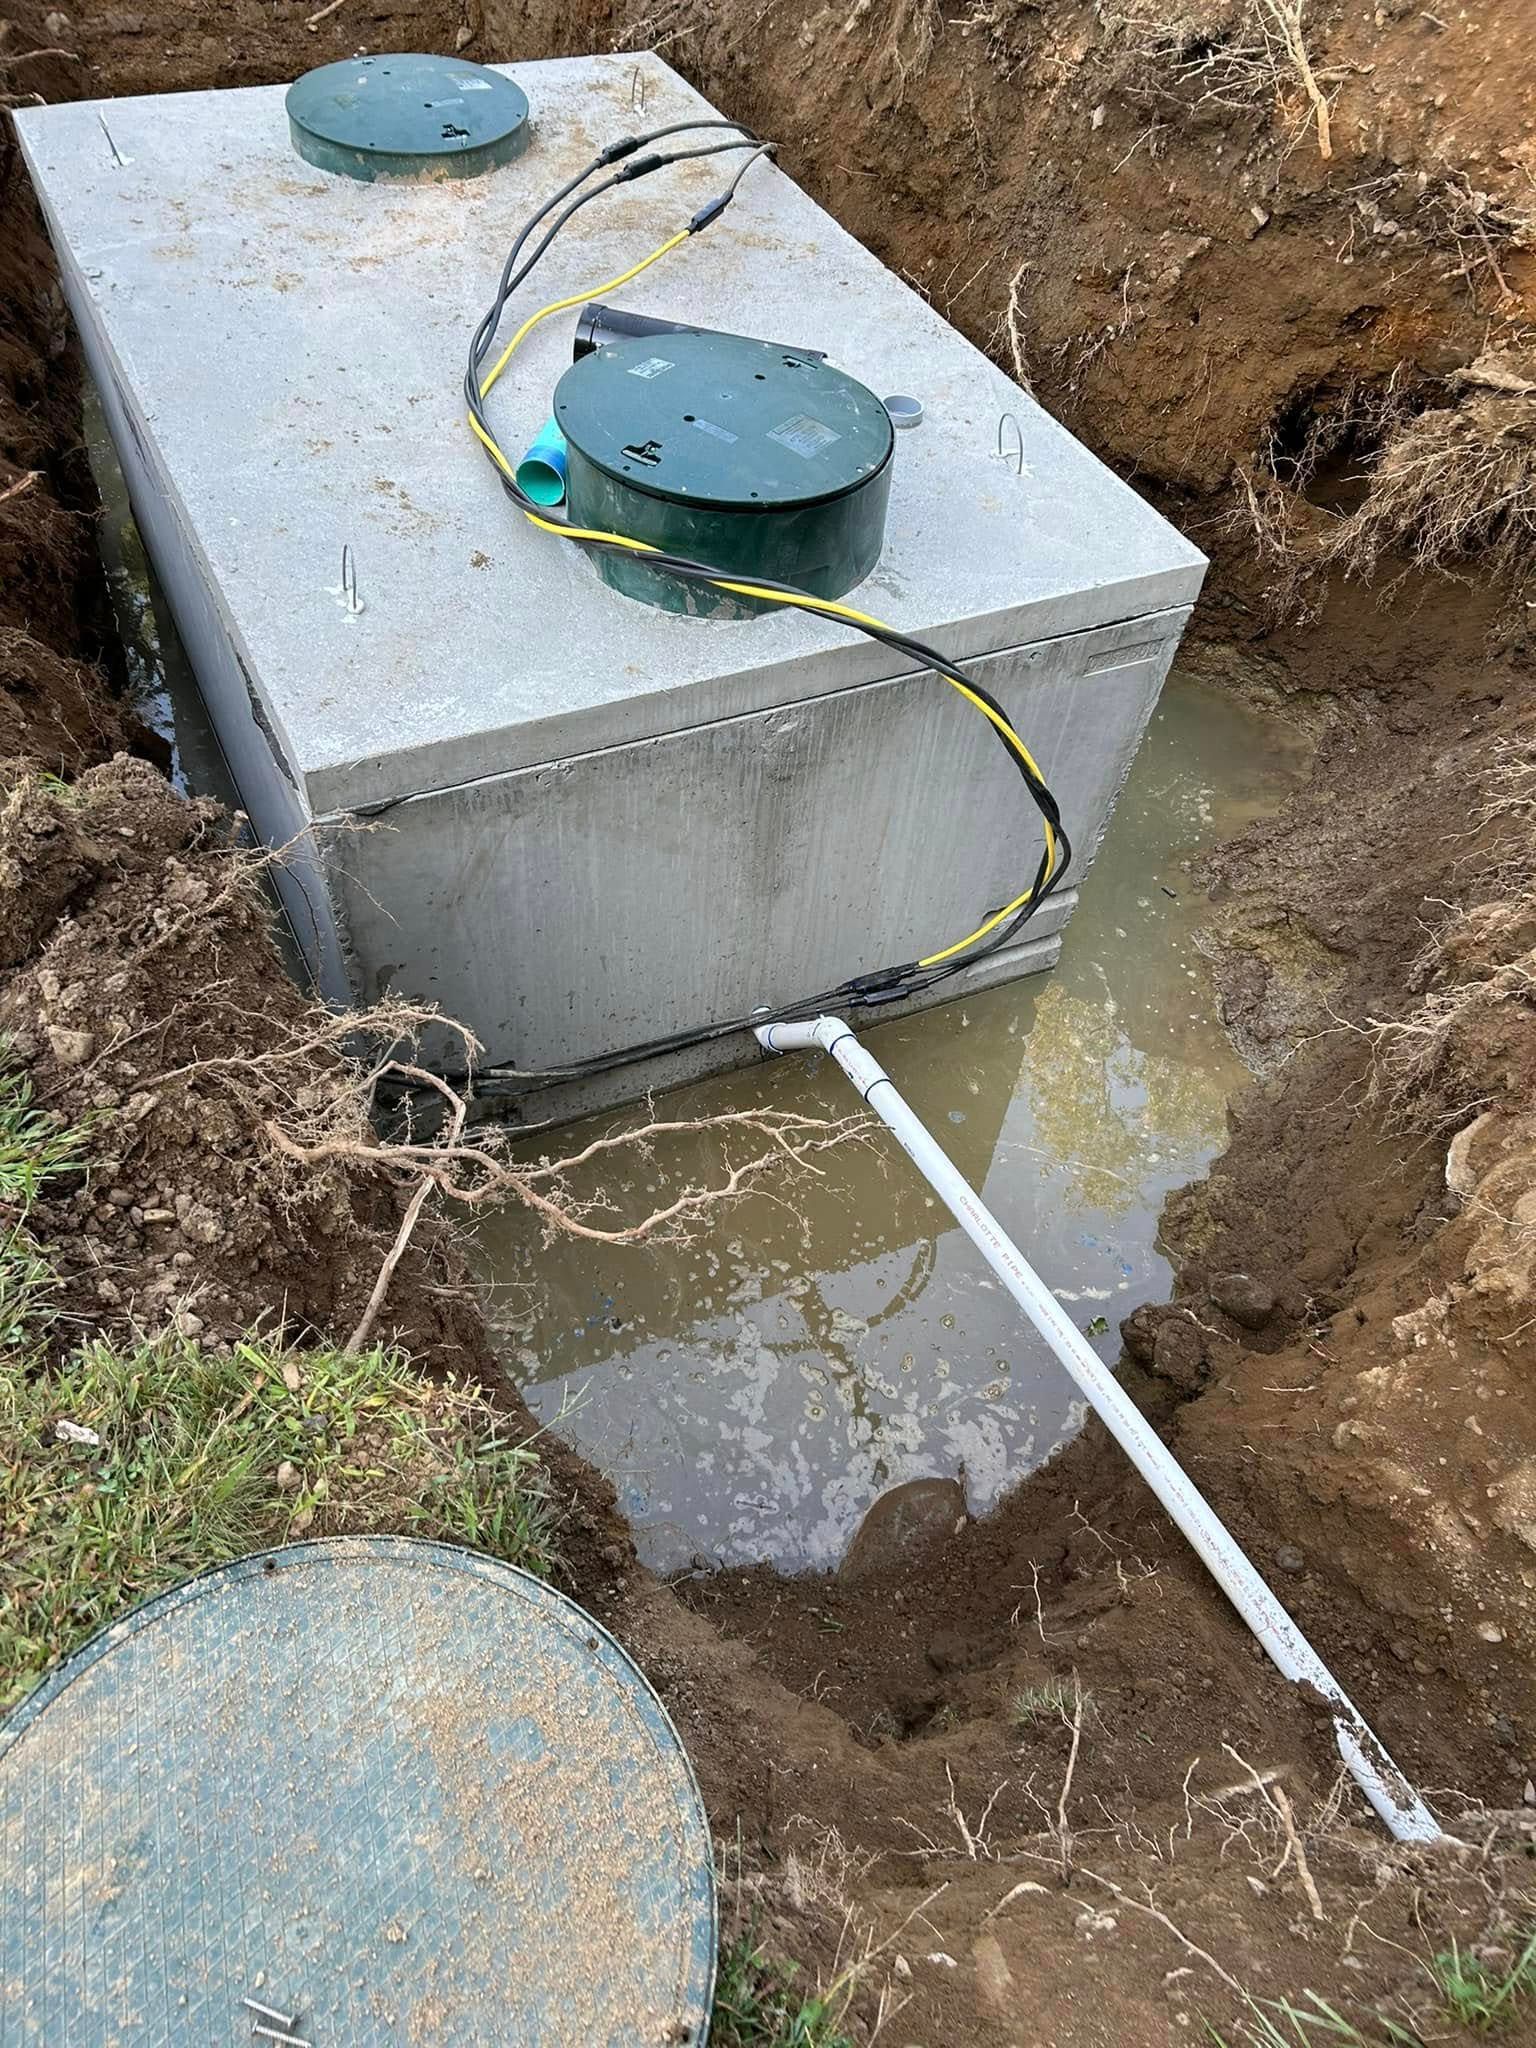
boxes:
[477,678,1305,1569]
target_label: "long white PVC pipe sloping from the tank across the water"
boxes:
[758,1018,1442,1841]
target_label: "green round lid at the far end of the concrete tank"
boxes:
[285,55,528,182]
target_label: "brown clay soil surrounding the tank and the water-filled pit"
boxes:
[0,0,1536,2048]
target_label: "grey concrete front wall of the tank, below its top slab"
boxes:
[327,612,1188,1069]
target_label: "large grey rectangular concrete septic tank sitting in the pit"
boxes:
[14,55,1204,1116]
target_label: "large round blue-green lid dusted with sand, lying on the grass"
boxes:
[0,1536,715,2048]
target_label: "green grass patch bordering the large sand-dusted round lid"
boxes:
[0,1335,555,1708]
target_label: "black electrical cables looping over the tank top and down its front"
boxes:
[403,136,1071,1094]
